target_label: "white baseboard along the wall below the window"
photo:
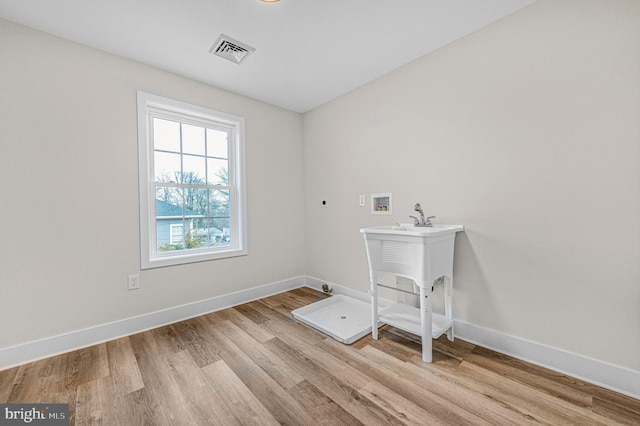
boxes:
[0,276,305,370]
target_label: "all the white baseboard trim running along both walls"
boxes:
[0,276,640,399]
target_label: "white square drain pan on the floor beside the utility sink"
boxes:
[291,294,371,345]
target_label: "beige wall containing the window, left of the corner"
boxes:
[0,21,304,348]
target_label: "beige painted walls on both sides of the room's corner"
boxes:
[0,0,640,370]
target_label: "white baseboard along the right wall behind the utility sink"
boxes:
[305,276,640,399]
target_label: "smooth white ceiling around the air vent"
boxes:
[0,0,536,112]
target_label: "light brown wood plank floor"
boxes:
[0,288,640,426]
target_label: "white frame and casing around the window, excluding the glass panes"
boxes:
[138,91,248,269]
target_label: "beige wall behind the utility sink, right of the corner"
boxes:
[304,0,640,370]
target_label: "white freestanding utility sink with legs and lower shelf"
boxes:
[360,225,464,362]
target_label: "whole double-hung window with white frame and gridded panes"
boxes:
[138,92,247,269]
